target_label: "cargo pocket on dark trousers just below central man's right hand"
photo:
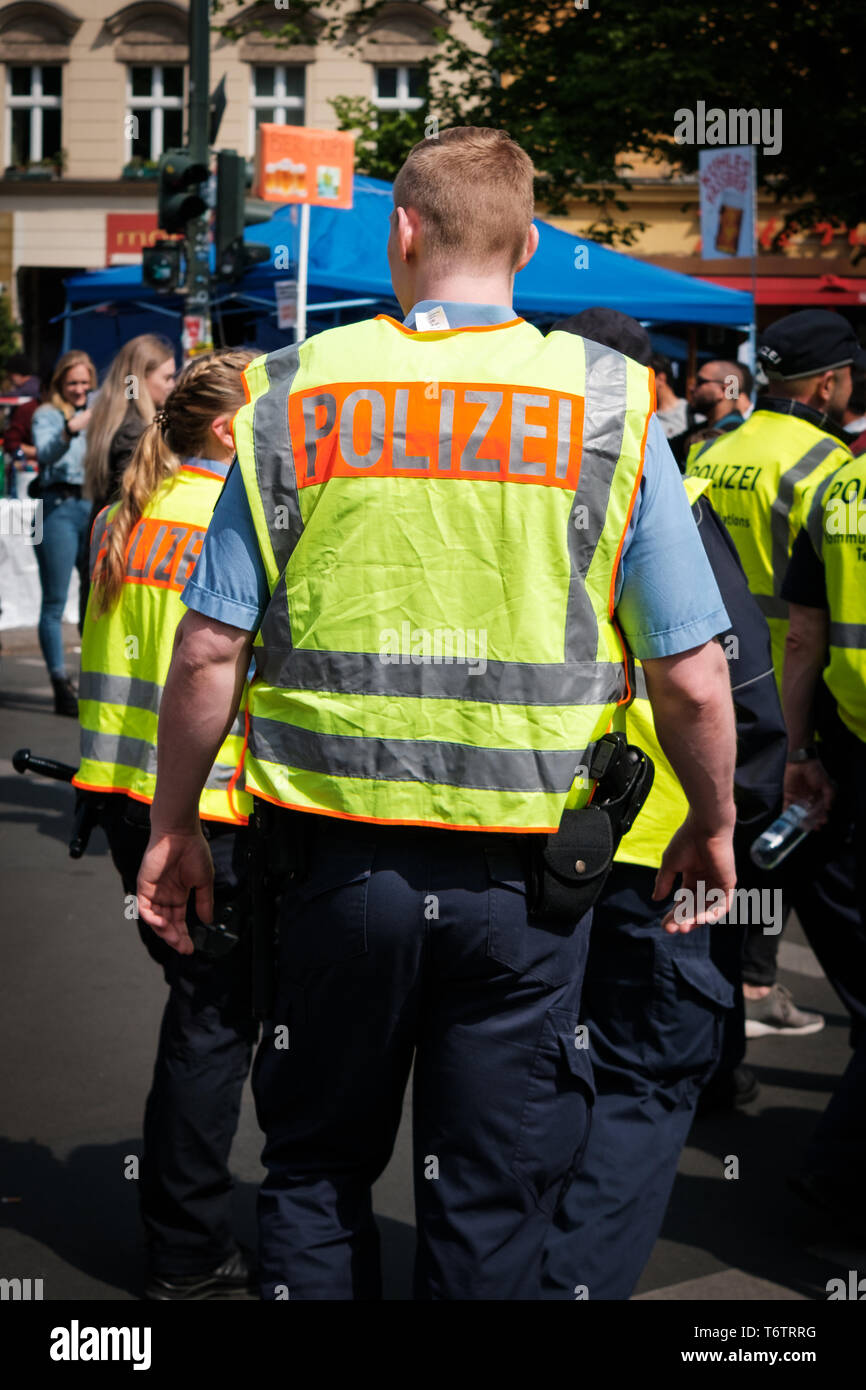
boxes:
[651,929,734,1102]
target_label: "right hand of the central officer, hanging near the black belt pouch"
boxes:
[652,813,737,934]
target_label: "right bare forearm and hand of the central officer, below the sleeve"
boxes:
[642,641,737,931]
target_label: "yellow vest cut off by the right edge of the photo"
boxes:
[808,456,866,742]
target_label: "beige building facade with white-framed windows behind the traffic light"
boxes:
[0,0,467,354]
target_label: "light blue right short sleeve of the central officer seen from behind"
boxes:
[616,416,731,660]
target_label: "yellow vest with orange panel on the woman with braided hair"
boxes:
[72,459,252,824]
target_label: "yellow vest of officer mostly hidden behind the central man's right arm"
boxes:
[614,478,710,869]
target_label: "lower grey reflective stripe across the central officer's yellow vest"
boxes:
[250,716,587,792]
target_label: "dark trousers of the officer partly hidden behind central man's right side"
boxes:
[542,865,742,1300]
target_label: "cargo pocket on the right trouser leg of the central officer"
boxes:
[512,1009,595,1213]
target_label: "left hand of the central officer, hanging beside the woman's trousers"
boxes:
[138,828,214,955]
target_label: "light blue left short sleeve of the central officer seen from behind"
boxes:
[181,464,271,632]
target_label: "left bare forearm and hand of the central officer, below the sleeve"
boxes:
[138,612,253,955]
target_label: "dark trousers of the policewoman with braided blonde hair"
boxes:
[103,795,257,1275]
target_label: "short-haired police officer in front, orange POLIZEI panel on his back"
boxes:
[139,128,734,1300]
